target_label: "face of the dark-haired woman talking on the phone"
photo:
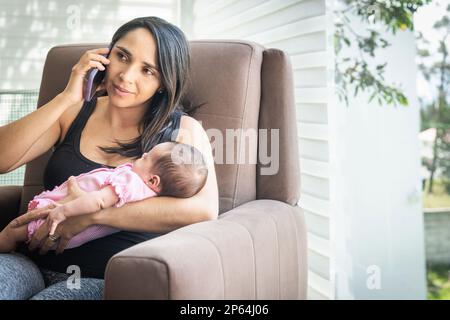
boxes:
[106,28,161,107]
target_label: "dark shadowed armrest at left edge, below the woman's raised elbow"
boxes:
[0,186,22,230]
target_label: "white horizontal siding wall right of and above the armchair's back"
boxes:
[189,0,334,299]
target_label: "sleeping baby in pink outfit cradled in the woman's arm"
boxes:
[0,142,208,253]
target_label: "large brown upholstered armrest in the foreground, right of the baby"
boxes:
[104,200,307,299]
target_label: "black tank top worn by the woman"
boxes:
[19,98,184,278]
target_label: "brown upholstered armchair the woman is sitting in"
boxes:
[0,40,307,299]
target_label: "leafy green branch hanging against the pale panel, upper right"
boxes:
[335,0,430,105]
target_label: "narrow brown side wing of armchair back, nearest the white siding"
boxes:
[257,49,300,205]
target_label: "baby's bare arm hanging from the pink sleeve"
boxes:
[47,185,119,235]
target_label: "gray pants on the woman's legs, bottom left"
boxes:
[0,253,104,300]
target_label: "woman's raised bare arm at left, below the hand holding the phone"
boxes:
[0,93,76,173]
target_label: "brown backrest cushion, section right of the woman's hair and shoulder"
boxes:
[183,40,264,213]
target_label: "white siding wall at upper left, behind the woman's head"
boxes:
[0,0,178,90]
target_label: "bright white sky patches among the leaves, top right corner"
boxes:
[414,0,450,101]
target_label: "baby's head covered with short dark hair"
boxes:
[152,142,208,198]
